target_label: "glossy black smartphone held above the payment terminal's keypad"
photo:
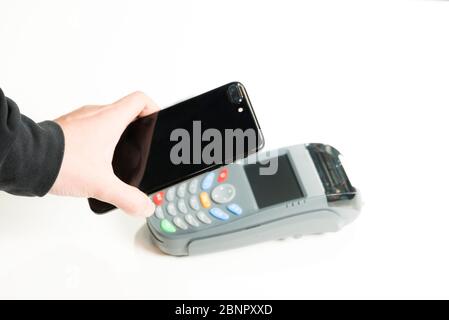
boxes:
[89,82,264,214]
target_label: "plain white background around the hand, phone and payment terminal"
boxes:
[0,0,449,299]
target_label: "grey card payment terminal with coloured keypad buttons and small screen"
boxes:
[147,143,361,256]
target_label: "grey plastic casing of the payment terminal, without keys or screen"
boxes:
[147,144,361,256]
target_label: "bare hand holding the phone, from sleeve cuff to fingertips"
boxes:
[50,92,158,217]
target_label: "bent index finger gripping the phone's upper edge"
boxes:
[112,91,159,124]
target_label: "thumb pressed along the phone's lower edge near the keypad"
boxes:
[99,176,155,217]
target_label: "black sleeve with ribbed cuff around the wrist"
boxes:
[0,89,64,197]
